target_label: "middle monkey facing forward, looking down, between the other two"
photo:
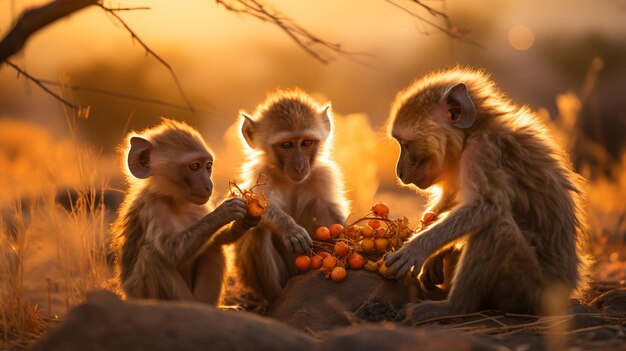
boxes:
[237,90,348,300]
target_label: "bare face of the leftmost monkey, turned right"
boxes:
[179,152,213,205]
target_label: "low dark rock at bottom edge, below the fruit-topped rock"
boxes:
[316,323,496,351]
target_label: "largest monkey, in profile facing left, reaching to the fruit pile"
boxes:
[386,68,586,319]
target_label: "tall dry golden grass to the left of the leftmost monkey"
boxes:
[0,113,115,349]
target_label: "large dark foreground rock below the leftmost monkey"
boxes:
[33,291,314,351]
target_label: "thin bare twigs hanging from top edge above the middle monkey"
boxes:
[215,0,372,66]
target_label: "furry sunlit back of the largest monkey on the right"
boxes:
[484,108,587,288]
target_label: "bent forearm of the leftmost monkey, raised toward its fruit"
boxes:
[155,198,247,266]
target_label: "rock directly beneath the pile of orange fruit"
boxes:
[267,270,411,332]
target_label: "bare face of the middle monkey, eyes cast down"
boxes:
[272,136,319,183]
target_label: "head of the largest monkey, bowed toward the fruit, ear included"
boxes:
[390,83,476,189]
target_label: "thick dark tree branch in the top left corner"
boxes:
[0,0,99,62]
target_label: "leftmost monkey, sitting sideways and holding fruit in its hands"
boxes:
[112,119,260,304]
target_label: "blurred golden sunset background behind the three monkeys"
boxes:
[0,0,626,340]
